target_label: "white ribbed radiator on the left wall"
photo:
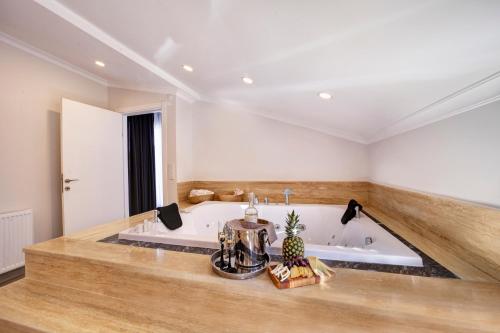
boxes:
[0,209,33,274]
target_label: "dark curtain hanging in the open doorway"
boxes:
[127,113,156,215]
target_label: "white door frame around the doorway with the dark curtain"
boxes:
[117,102,167,217]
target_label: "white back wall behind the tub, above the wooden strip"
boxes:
[188,103,369,181]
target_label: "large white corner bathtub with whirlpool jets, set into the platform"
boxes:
[119,202,422,267]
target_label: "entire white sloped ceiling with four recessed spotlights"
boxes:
[0,0,500,143]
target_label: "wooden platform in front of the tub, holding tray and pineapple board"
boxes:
[0,214,500,332]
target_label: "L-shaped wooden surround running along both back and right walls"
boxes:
[179,181,500,282]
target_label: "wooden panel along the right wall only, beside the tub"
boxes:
[367,183,500,282]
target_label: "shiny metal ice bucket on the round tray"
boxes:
[225,219,270,267]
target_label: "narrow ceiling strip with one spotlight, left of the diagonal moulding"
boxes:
[0,0,175,92]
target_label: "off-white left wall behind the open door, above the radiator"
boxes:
[0,42,108,241]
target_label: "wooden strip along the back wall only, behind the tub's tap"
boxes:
[177,181,369,205]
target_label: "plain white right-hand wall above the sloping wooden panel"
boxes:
[369,102,500,206]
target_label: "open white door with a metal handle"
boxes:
[61,98,125,235]
